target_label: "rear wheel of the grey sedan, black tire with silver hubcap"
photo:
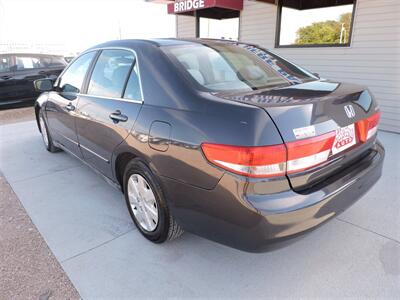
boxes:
[123,158,183,243]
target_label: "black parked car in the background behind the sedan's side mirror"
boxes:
[0,53,67,108]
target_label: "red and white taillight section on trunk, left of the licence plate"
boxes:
[286,131,335,173]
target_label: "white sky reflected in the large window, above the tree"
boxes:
[280,5,353,45]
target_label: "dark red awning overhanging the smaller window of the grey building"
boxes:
[168,0,243,19]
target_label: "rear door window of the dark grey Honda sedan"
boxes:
[88,50,135,98]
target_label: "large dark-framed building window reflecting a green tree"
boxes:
[275,0,356,47]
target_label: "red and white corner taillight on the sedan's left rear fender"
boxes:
[201,143,286,177]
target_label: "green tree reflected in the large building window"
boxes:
[295,13,352,45]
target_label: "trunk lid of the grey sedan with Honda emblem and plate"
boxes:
[217,81,379,191]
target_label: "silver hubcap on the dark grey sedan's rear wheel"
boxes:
[128,174,158,232]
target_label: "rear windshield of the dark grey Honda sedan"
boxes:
[162,43,317,92]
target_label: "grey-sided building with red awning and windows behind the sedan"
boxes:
[156,0,400,132]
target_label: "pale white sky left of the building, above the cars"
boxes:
[0,0,175,55]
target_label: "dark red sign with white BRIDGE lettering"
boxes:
[168,0,243,14]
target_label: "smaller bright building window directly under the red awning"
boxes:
[197,17,239,41]
